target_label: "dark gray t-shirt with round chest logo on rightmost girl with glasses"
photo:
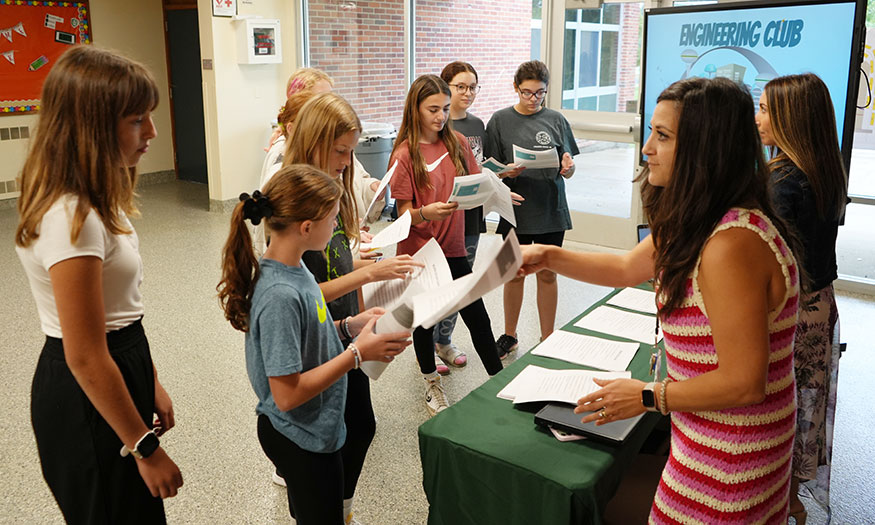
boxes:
[483,106,580,235]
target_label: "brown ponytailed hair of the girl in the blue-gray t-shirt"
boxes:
[216,164,343,332]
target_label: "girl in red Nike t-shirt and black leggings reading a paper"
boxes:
[389,75,502,415]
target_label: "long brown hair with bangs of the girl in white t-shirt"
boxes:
[15,46,158,247]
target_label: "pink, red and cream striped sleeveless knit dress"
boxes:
[650,208,799,525]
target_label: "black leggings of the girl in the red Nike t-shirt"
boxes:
[413,257,502,376]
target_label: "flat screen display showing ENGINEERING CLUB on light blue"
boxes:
[641,1,865,166]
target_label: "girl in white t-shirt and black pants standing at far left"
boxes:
[15,46,182,523]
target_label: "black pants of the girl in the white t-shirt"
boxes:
[31,321,165,524]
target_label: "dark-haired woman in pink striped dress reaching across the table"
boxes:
[523,78,799,524]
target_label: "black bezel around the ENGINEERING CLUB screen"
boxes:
[638,0,866,172]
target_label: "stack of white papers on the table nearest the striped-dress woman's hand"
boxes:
[498,365,632,405]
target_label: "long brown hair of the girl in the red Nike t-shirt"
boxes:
[390,75,468,191]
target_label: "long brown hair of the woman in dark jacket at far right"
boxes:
[764,73,847,220]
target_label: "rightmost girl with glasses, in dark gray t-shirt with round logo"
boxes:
[484,60,579,359]
